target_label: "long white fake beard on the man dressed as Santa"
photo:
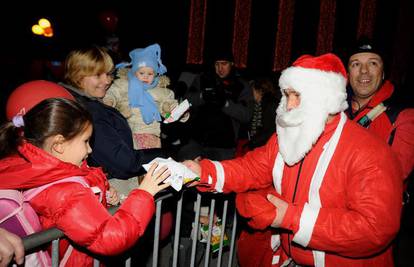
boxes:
[276,98,328,166]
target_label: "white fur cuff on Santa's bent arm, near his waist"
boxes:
[292,203,319,247]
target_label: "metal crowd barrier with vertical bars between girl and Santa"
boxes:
[23,189,237,267]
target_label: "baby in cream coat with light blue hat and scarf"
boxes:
[103,44,189,149]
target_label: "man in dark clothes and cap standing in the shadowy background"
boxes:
[177,50,254,160]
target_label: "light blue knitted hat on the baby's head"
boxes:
[129,44,167,74]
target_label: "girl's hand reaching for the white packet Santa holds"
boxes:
[138,163,171,196]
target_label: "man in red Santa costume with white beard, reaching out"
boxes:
[184,54,402,267]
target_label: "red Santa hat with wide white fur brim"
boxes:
[279,53,348,114]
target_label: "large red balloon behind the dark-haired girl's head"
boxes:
[6,80,75,120]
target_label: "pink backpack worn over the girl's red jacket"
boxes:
[0,176,94,267]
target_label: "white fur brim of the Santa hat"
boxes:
[279,67,348,114]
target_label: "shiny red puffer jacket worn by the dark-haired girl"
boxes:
[0,143,155,266]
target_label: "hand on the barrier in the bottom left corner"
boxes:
[0,228,24,267]
